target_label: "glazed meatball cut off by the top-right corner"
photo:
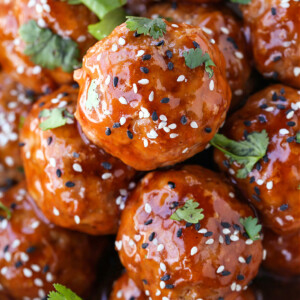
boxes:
[241,0,300,88]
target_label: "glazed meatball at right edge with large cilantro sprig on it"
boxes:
[215,84,300,234]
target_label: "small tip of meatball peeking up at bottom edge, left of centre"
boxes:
[109,272,148,300]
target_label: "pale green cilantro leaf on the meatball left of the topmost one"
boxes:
[39,108,74,131]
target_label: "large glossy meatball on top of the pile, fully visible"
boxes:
[75,21,231,170]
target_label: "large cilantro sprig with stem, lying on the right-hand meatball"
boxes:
[210,130,269,178]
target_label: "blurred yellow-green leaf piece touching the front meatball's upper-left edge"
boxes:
[88,8,126,40]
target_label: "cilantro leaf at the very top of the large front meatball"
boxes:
[126,17,167,40]
